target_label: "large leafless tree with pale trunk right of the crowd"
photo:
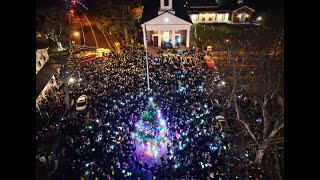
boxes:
[216,26,284,177]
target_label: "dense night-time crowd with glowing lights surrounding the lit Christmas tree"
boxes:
[37,49,262,180]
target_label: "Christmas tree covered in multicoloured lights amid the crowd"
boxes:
[135,98,169,158]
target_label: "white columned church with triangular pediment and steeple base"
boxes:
[141,0,192,48]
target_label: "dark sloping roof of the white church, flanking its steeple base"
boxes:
[141,0,192,23]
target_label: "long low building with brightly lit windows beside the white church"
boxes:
[186,0,255,24]
